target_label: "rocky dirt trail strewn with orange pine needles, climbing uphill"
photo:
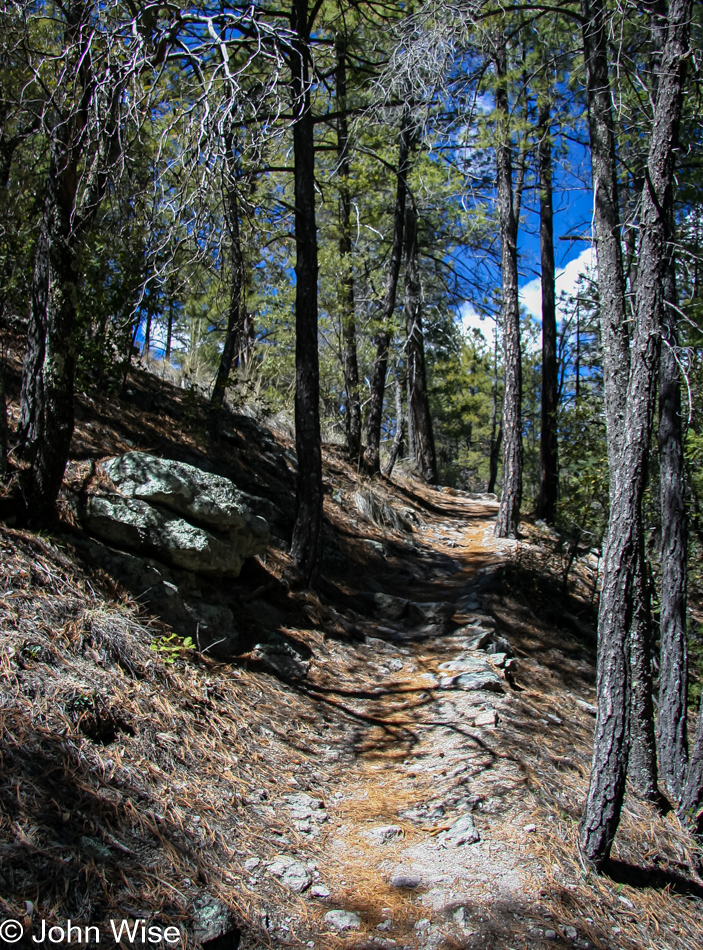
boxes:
[288,496,540,948]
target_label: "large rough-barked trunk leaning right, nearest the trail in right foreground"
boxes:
[580,0,691,869]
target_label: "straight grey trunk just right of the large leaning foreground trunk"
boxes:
[657,255,688,802]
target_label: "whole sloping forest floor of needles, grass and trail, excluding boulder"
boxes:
[0,358,703,950]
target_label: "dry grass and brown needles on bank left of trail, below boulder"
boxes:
[0,528,348,948]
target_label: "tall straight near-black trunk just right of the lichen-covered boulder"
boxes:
[290,0,322,582]
